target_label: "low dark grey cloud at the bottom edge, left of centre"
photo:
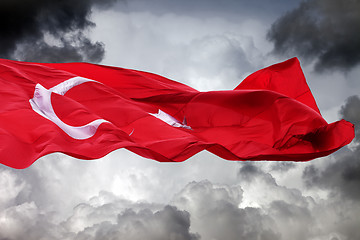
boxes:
[75,206,199,240]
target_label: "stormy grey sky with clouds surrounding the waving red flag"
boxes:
[0,0,360,240]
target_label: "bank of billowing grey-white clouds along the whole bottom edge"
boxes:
[0,163,360,240]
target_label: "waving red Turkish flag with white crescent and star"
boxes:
[0,58,354,168]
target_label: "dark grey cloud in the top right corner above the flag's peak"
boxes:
[268,0,360,71]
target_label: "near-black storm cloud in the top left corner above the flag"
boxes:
[0,0,116,62]
